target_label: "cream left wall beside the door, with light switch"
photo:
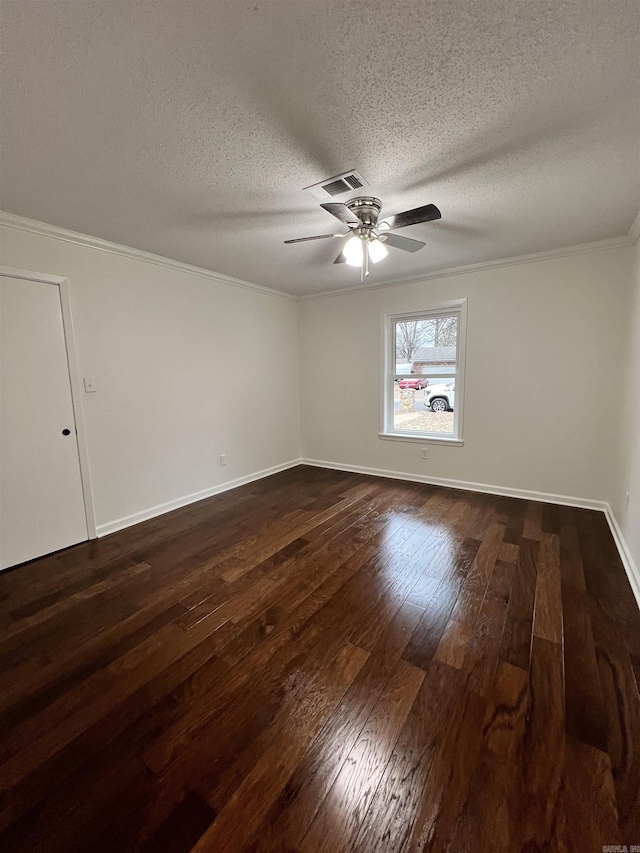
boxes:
[0,227,300,528]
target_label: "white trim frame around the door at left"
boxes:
[0,266,98,539]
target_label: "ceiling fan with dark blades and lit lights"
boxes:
[284,196,442,281]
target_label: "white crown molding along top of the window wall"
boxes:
[298,231,640,302]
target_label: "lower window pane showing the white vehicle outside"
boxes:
[393,376,456,435]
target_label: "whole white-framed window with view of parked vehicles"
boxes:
[380,299,466,444]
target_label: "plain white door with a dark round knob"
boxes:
[0,276,88,569]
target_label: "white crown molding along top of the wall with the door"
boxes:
[0,211,298,302]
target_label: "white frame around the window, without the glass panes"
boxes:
[378,299,467,446]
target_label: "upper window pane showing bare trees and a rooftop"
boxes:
[393,314,458,376]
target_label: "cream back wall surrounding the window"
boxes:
[300,248,637,501]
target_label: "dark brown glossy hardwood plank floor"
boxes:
[0,467,640,853]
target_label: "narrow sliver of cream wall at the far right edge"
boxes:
[609,241,640,580]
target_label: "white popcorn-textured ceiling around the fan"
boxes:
[0,0,640,294]
